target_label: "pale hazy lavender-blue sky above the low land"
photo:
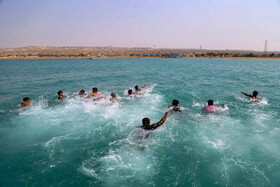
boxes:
[0,0,280,51]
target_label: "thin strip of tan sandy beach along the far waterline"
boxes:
[0,56,280,60]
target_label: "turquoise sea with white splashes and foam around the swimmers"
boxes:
[0,59,280,186]
